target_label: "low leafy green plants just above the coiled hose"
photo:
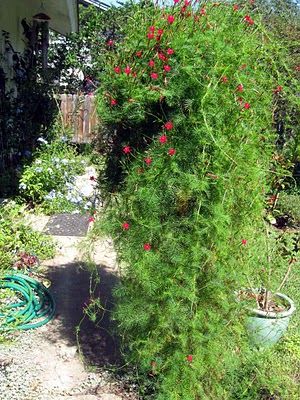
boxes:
[0,202,55,272]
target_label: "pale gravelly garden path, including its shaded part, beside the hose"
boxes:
[0,217,138,400]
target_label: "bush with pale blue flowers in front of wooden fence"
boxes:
[19,132,92,213]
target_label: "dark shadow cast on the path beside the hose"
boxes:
[47,262,121,367]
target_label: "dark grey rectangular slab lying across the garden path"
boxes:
[43,214,89,236]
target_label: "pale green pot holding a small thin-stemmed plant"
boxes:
[237,228,298,348]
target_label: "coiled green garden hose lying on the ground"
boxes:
[0,273,55,332]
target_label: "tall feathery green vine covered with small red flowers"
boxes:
[94,1,296,400]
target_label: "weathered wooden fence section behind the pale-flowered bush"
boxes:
[60,94,98,143]
